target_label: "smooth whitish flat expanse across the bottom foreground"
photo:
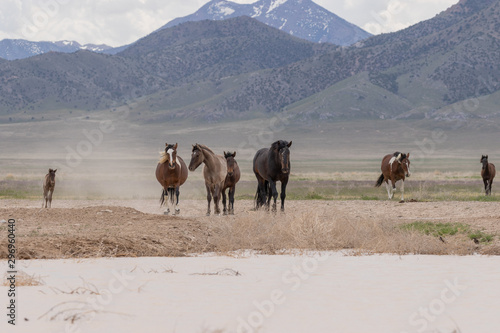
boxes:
[0,253,500,333]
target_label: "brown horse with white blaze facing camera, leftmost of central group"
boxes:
[156,143,188,215]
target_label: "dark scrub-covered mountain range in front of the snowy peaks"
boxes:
[0,0,500,126]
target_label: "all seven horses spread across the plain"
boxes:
[42,140,496,211]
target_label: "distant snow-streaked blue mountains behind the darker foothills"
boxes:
[0,0,371,60]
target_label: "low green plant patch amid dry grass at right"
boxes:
[400,221,494,243]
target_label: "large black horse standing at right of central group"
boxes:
[253,140,292,211]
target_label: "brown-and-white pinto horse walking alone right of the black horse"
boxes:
[375,152,411,201]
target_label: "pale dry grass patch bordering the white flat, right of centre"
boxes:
[210,210,488,255]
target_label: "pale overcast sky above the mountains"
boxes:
[0,0,458,46]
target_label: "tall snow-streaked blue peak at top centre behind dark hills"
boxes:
[160,0,371,46]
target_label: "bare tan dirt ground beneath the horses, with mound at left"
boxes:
[0,200,500,259]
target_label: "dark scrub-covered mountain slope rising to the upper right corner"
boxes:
[206,0,500,117]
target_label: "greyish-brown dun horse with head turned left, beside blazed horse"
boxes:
[189,144,227,216]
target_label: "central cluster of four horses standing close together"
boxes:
[156,140,292,216]
